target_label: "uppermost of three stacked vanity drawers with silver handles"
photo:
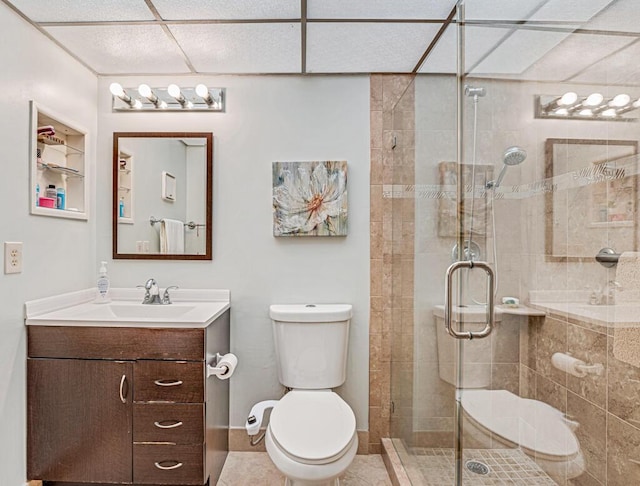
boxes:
[133,361,205,403]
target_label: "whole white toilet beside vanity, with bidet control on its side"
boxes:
[246,304,358,486]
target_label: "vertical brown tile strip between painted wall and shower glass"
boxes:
[369,75,415,454]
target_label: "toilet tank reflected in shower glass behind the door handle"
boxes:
[433,305,502,388]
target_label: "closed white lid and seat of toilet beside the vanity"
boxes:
[269,390,357,464]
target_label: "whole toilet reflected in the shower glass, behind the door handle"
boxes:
[433,305,585,484]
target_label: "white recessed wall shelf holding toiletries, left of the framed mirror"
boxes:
[29,101,88,220]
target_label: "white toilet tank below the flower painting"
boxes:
[269,304,352,390]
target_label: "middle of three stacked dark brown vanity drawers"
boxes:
[133,403,204,444]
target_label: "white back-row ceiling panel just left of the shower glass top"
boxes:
[307,22,441,73]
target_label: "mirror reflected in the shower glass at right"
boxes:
[545,138,638,262]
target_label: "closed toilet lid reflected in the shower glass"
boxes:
[461,390,580,461]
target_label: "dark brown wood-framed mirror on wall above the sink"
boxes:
[112,132,213,260]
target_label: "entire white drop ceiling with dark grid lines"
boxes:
[0,0,640,84]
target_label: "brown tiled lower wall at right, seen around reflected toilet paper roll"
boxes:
[520,315,640,486]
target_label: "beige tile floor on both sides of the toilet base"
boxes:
[218,452,391,486]
